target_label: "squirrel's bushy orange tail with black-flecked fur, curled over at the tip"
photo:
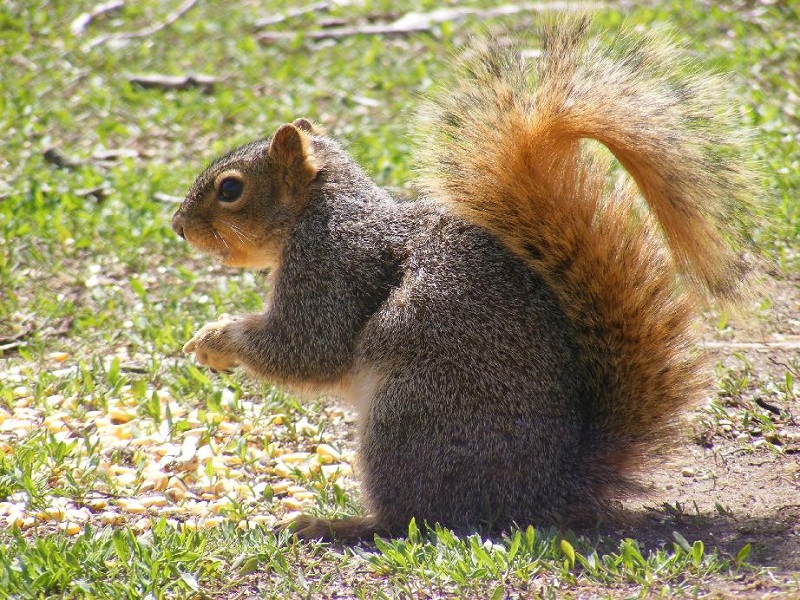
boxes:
[420,18,754,486]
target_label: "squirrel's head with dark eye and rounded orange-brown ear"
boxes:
[172,119,321,269]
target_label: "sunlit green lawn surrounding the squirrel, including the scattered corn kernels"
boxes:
[0,0,800,598]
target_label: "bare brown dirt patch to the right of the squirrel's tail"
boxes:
[617,276,800,598]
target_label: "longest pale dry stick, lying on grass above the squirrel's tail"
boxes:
[256,2,605,43]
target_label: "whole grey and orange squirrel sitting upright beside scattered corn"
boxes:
[172,17,754,542]
